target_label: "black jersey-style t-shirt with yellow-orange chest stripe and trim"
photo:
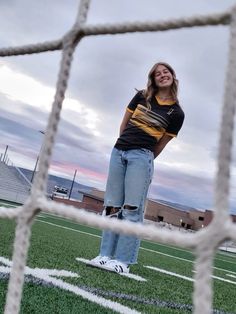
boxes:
[115,91,184,151]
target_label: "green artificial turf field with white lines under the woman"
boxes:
[0,210,236,314]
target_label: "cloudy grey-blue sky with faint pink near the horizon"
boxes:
[0,0,236,212]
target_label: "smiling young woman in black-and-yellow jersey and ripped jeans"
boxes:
[91,62,184,273]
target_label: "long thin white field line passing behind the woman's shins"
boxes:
[35,219,236,274]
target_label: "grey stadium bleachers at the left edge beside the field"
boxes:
[0,162,31,204]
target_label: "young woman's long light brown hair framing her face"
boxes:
[144,62,179,103]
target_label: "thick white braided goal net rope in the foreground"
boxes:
[0,0,236,314]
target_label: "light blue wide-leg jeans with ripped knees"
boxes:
[100,148,154,264]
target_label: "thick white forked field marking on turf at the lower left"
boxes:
[0,256,141,314]
